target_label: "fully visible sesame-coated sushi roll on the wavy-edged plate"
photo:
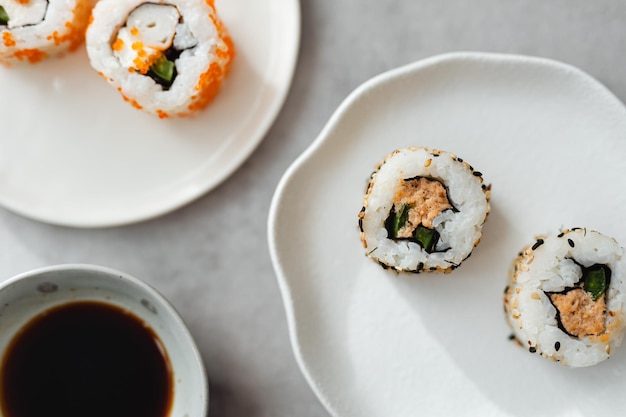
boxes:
[358,147,491,272]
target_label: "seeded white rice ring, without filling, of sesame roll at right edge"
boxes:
[504,229,626,367]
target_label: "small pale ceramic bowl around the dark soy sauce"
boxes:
[0,264,209,417]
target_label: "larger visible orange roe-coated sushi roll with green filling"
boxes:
[86,0,235,118]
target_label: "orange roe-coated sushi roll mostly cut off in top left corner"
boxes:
[0,0,95,66]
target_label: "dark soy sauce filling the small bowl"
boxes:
[0,301,173,417]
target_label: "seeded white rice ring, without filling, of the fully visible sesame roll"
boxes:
[359,147,490,272]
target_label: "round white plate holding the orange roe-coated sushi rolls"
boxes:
[0,0,300,227]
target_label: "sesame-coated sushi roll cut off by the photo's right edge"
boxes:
[504,228,626,367]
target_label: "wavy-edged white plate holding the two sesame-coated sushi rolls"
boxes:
[269,53,626,417]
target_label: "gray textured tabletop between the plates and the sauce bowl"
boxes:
[0,0,626,417]
